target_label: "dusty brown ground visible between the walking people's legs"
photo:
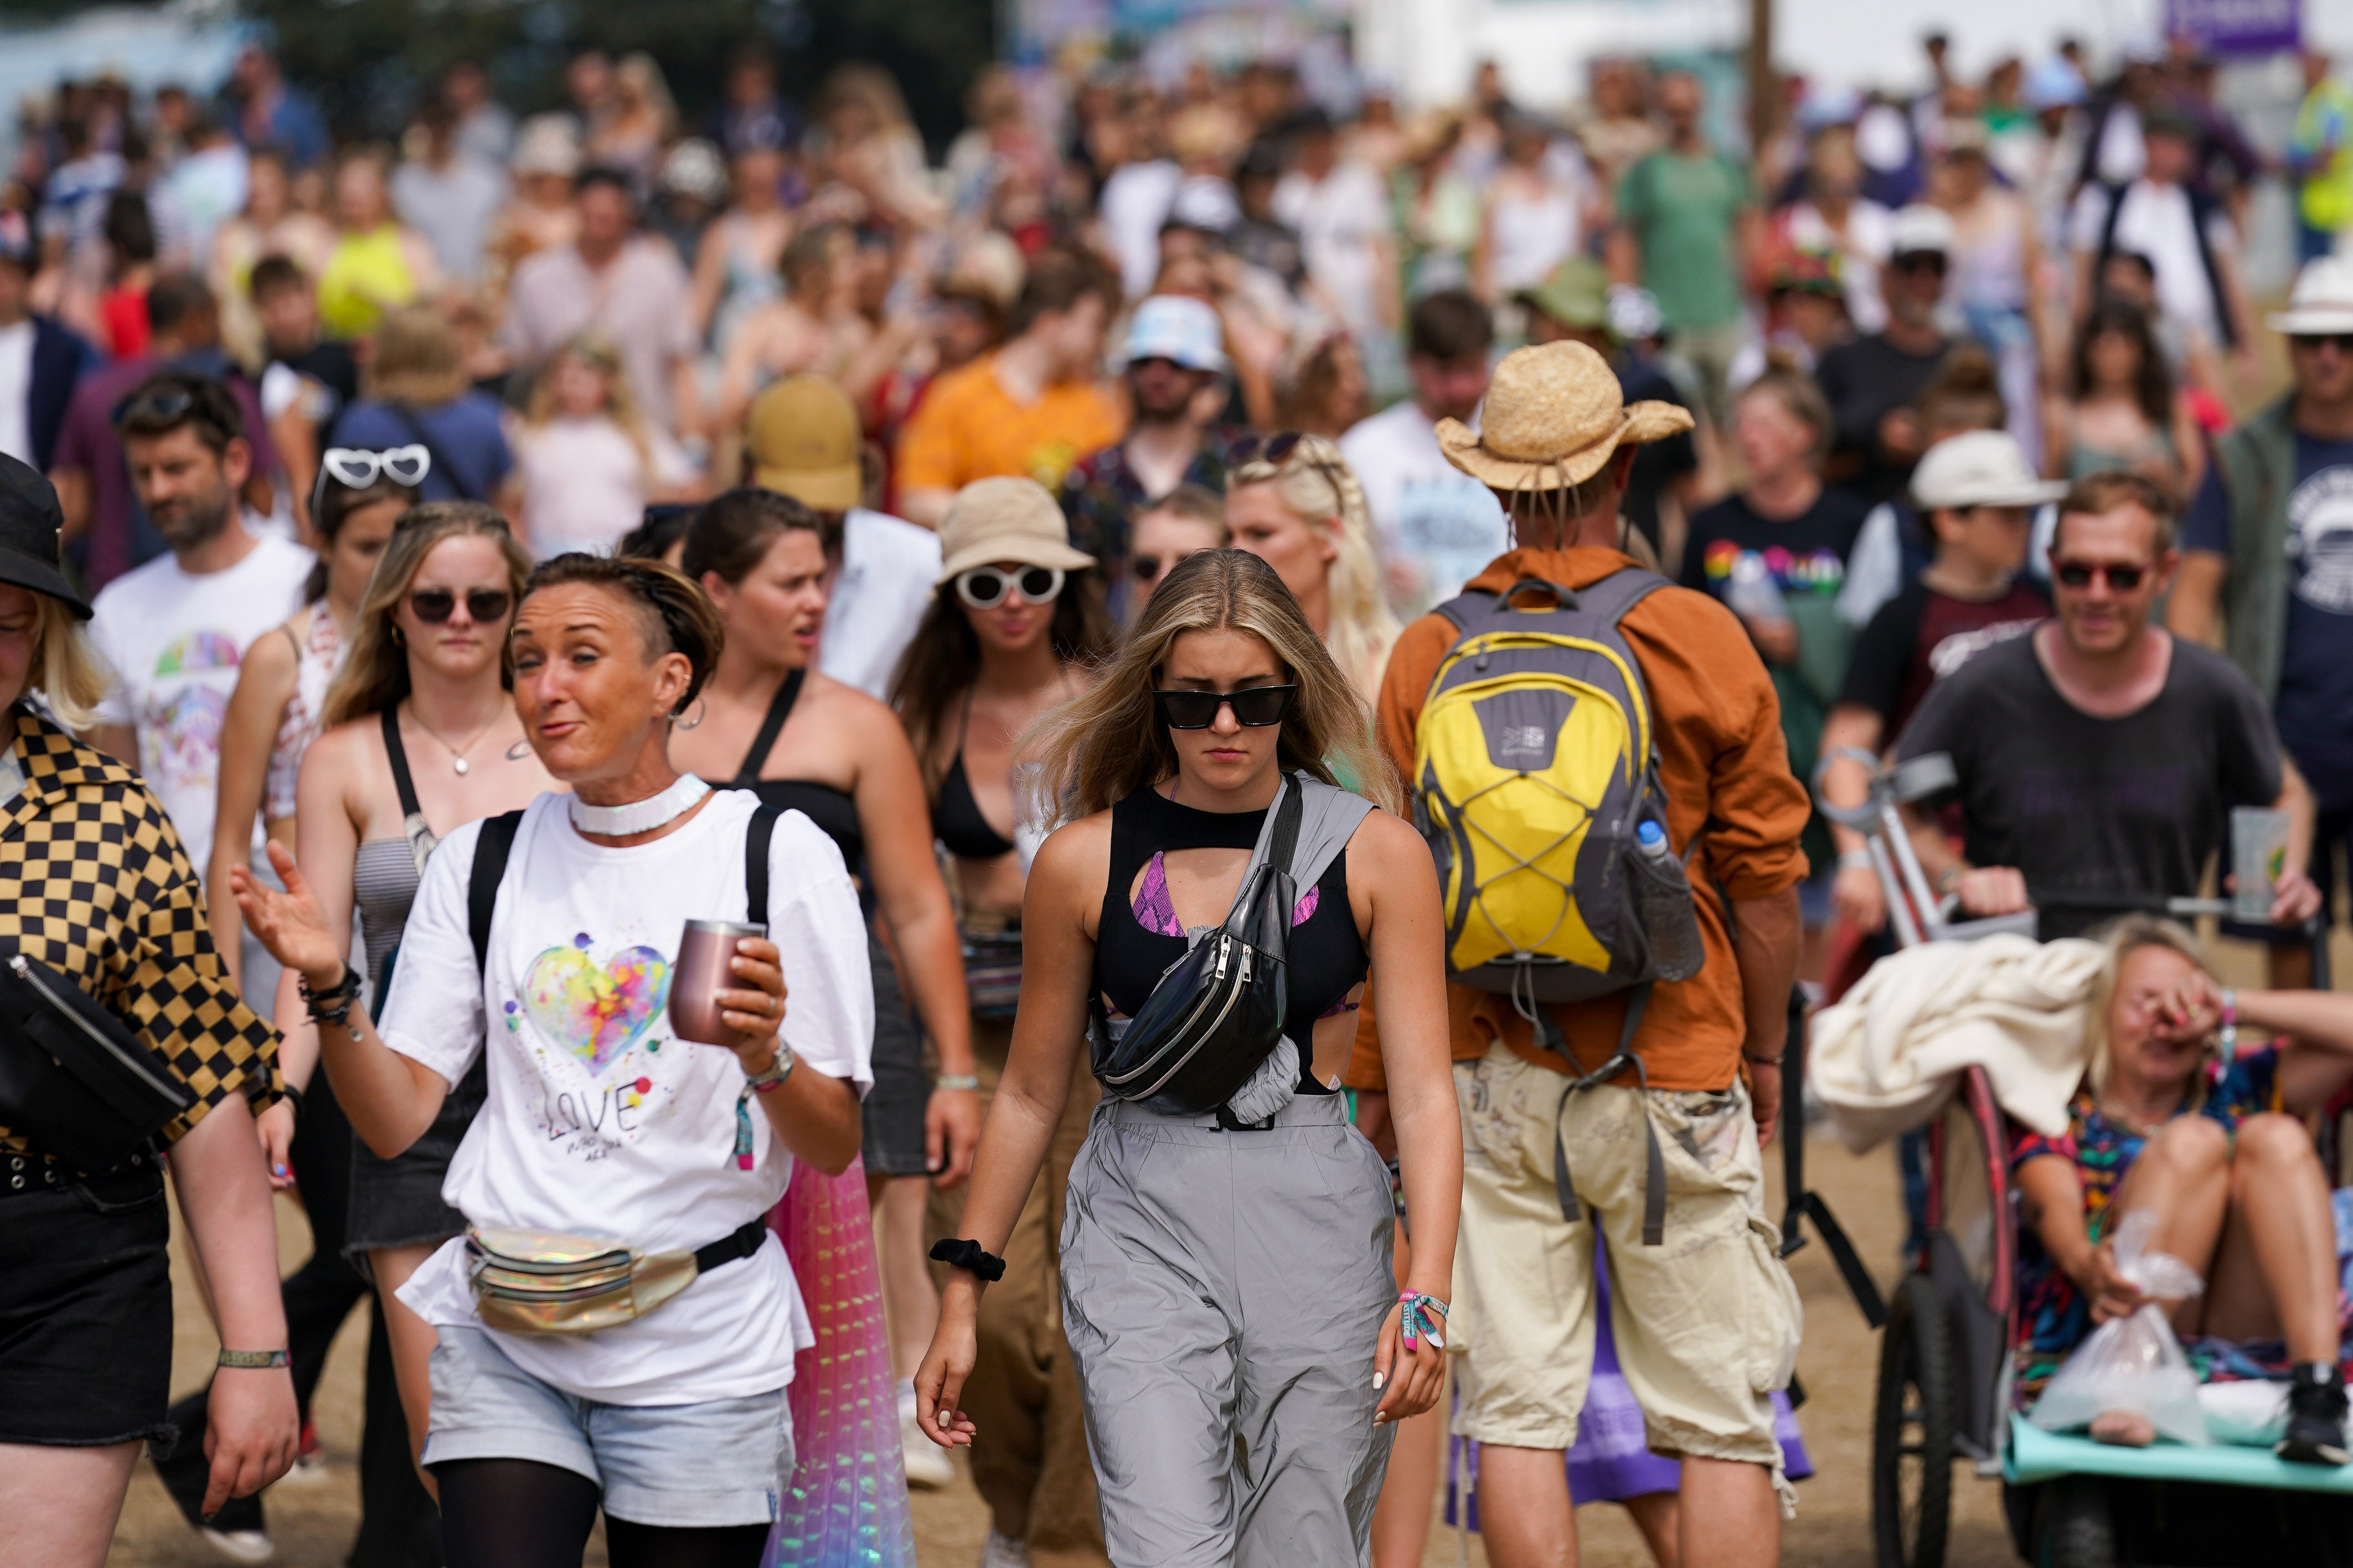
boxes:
[106,935,2297,1568]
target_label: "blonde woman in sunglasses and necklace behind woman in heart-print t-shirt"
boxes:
[278,501,558,1486]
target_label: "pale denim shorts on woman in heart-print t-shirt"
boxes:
[424,1326,793,1528]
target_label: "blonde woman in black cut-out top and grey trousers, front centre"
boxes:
[915,550,1461,1568]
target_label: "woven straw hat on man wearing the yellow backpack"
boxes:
[1438,343,1692,491]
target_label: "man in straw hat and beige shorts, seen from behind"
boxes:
[1348,341,1807,1568]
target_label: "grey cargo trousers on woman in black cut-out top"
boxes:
[1061,1095,1398,1568]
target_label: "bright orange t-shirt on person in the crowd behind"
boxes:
[896,355,1127,491]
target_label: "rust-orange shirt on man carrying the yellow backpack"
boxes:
[1348,548,1809,1091]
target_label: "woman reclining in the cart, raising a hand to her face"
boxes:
[2012,914,2353,1464]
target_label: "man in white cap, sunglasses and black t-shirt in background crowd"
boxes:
[1814,205,1953,505]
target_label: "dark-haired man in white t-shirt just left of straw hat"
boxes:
[1339,289,1511,616]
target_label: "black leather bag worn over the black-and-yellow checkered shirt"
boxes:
[0,954,195,1171]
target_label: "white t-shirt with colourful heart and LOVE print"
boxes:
[379,790,873,1406]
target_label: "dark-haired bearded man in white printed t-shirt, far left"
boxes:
[90,371,316,865]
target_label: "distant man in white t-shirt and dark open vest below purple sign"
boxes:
[2068,115,2252,350]
